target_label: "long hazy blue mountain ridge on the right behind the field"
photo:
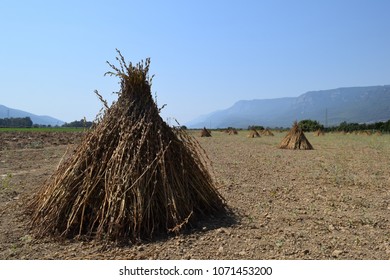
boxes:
[186,85,390,128]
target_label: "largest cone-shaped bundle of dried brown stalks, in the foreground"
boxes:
[30,51,226,242]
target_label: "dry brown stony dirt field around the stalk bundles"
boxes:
[0,131,390,260]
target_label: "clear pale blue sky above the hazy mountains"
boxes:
[0,0,390,123]
